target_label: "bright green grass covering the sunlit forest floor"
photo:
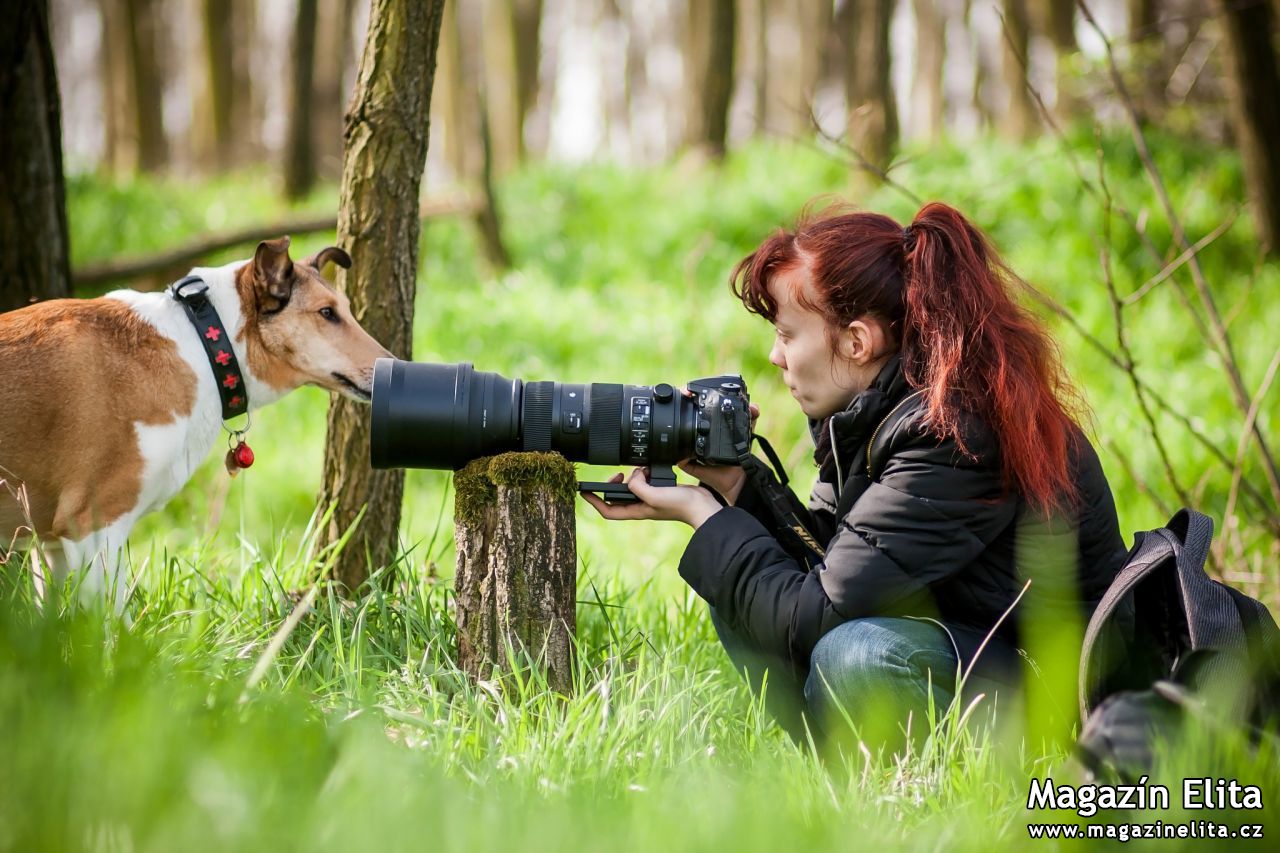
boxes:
[0,129,1280,850]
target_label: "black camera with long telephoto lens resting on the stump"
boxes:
[369,359,751,501]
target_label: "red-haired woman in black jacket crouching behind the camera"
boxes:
[586,204,1125,747]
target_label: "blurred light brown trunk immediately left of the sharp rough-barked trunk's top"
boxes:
[311,0,356,178]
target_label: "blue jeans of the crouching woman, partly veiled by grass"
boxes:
[712,608,1009,752]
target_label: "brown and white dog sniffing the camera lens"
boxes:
[0,237,390,610]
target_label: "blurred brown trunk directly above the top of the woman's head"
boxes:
[845,0,897,170]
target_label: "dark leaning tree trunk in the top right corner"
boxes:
[1216,0,1280,255]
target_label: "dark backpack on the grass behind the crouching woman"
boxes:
[1075,508,1280,779]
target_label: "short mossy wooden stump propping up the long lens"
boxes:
[453,452,577,693]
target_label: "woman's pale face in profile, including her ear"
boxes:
[769,260,884,419]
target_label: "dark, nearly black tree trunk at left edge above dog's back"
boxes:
[0,0,70,311]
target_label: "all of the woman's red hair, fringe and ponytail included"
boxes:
[730,202,1080,515]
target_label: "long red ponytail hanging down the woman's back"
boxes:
[901,202,1078,515]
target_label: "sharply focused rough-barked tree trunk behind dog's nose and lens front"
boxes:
[320,0,444,592]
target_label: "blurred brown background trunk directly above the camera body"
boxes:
[685,0,737,159]
